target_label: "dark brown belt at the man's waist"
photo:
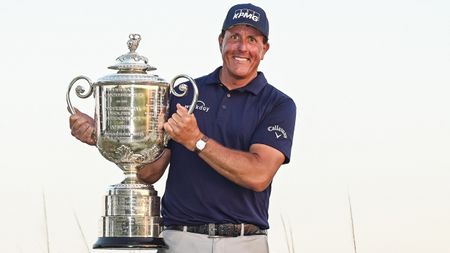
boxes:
[164,223,267,237]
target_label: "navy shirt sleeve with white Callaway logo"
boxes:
[251,98,297,164]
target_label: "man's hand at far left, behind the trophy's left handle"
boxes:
[69,109,96,145]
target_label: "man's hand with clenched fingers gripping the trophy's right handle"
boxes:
[164,104,202,151]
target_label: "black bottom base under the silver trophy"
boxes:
[93,237,168,249]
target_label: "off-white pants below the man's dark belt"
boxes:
[158,230,269,253]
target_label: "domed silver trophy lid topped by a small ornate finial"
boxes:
[99,34,165,82]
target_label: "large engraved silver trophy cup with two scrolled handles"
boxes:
[66,34,198,249]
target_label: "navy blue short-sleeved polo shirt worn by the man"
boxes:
[161,67,296,229]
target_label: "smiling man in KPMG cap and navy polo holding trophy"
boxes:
[70,4,296,253]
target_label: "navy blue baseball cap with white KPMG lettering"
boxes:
[222,4,269,39]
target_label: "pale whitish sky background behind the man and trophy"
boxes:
[0,0,450,253]
